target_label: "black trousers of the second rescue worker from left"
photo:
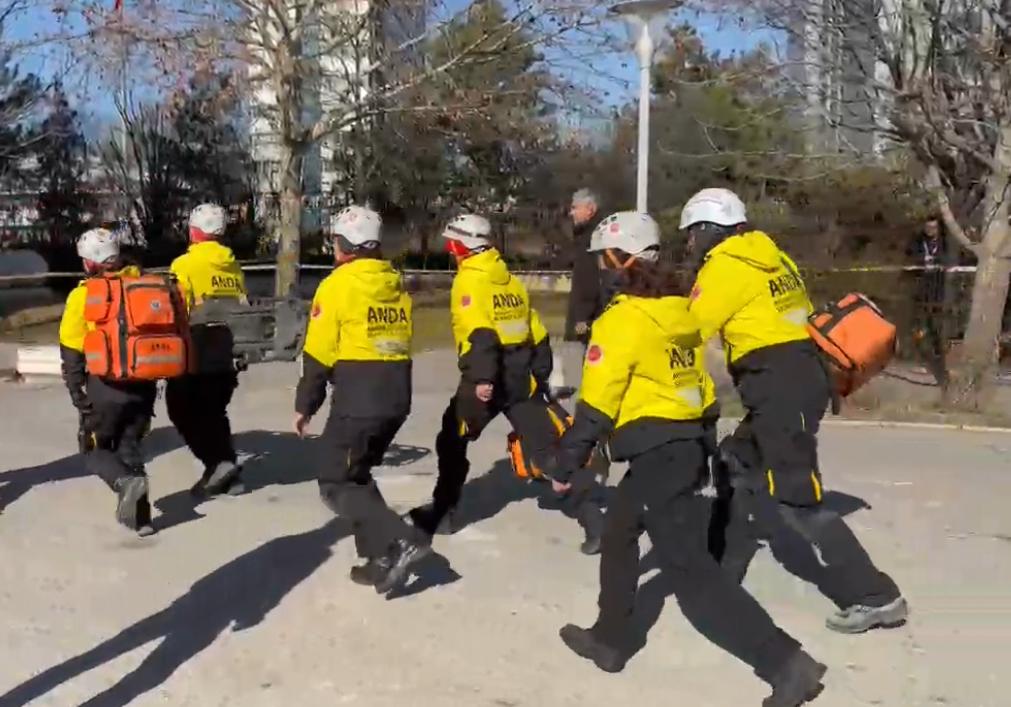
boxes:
[165,372,239,471]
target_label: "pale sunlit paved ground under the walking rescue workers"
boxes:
[0,354,1011,707]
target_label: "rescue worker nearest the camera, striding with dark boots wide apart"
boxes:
[553,211,825,707]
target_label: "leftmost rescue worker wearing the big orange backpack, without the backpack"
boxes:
[60,229,156,535]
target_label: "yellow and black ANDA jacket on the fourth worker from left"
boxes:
[450,249,551,404]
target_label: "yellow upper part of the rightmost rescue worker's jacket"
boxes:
[690,231,812,363]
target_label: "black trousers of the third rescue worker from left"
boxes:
[314,413,416,559]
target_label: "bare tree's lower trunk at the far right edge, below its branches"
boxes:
[948,252,1011,412]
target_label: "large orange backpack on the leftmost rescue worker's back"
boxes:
[84,275,189,380]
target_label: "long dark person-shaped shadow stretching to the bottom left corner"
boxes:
[0,519,349,707]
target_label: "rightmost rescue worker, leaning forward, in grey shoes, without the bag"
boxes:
[681,189,908,633]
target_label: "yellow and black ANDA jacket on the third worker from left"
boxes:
[295,258,413,418]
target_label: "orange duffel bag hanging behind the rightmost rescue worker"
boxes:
[808,293,896,397]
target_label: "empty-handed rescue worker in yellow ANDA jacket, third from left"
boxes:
[294,206,430,593]
